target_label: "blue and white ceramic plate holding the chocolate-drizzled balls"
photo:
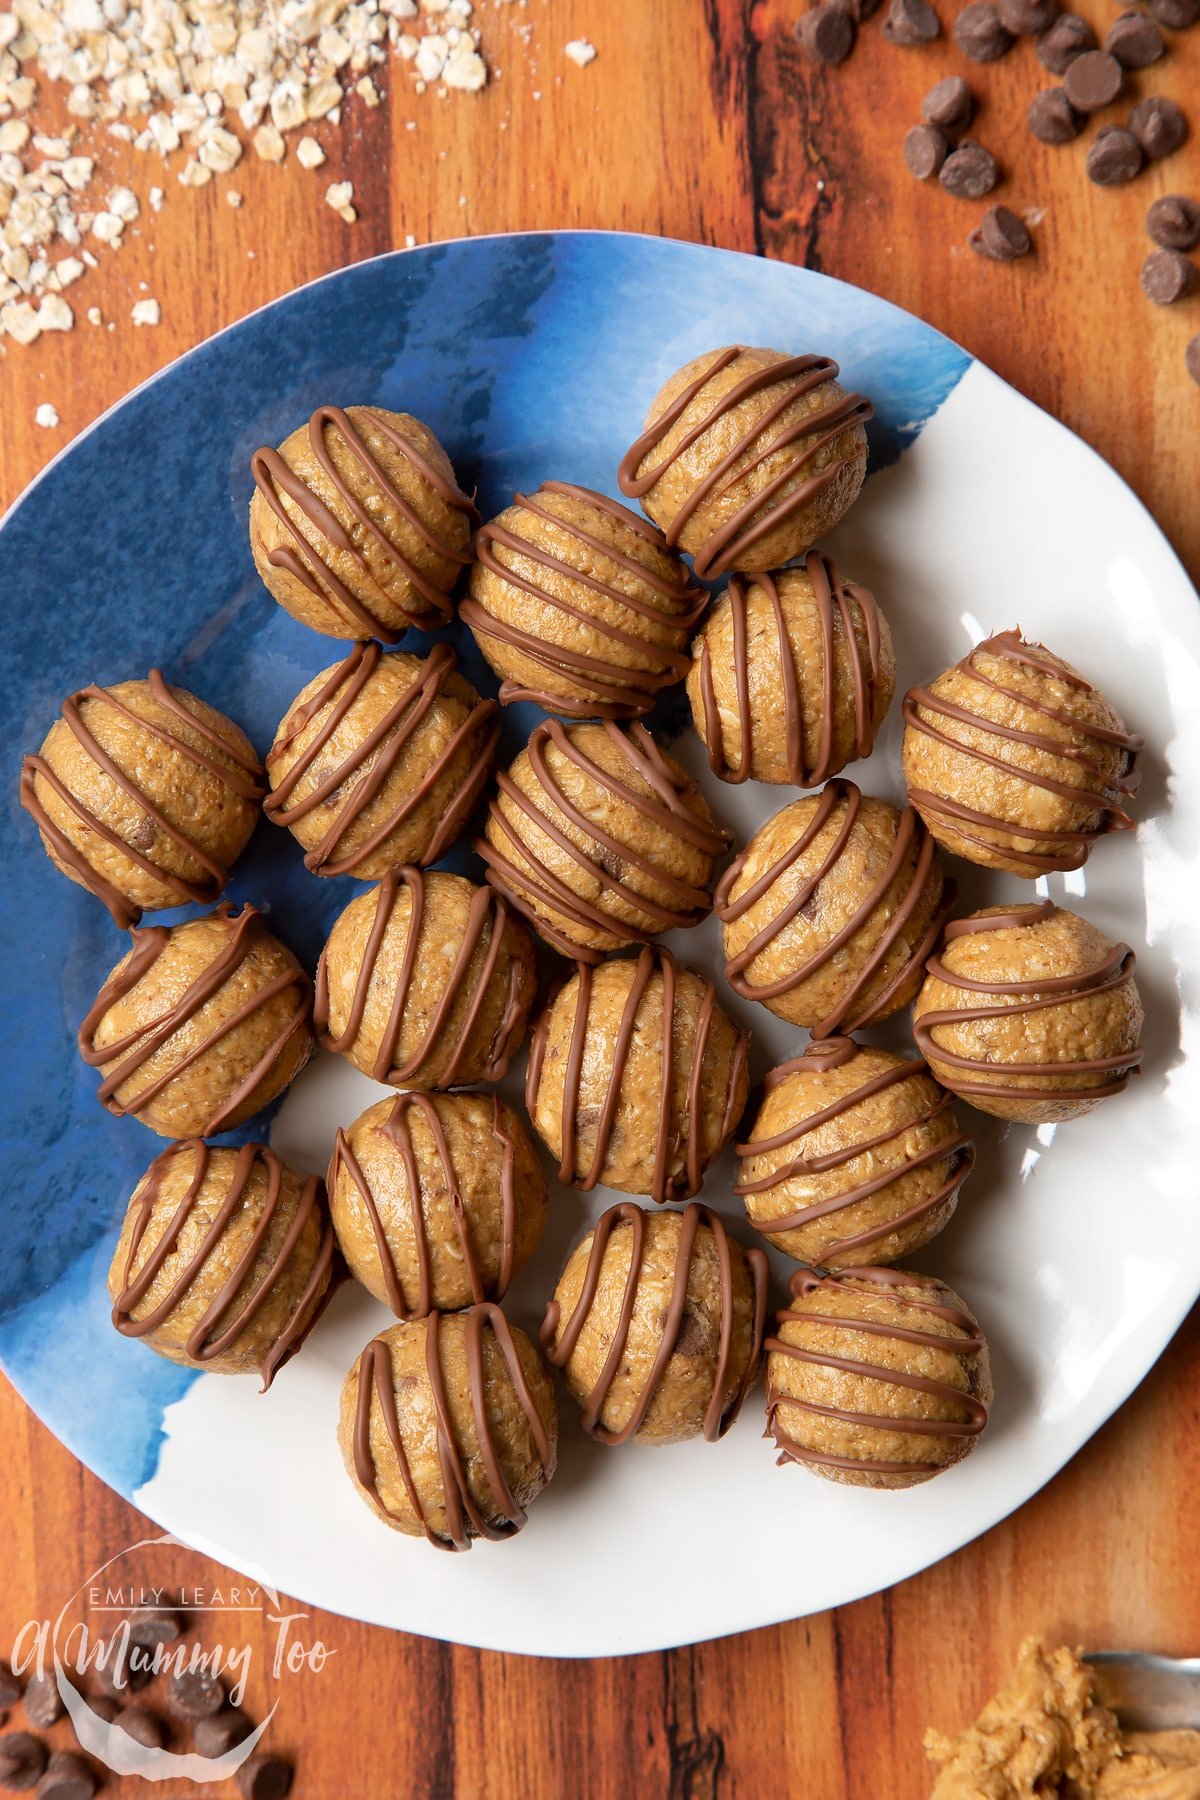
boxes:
[0,232,1200,1656]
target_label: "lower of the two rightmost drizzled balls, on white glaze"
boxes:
[912,900,1142,1125]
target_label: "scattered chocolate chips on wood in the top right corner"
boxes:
[795,0,1200,382]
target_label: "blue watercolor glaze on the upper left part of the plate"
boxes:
[0,232,970,1496]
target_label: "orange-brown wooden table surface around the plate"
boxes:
[0,0,1200,1800]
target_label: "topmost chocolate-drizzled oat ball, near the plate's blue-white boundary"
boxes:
[617,344,873,580]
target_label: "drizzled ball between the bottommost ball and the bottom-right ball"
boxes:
[542,1201,766,1444]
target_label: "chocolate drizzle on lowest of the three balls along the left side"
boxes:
[112,1138,335,1393]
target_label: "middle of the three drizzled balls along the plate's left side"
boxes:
[79,905,313,1138]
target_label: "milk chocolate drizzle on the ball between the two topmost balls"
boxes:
[459,481,709,718]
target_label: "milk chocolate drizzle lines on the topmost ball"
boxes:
[617,344,874,580]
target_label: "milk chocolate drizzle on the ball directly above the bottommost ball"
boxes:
[329,1094,516,1319]
